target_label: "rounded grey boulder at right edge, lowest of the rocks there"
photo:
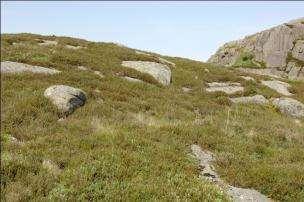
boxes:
[272,98,304,118]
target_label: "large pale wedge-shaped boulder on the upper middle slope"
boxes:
[122,61,171,86]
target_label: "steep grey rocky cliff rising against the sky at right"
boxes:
[208,18,304,80]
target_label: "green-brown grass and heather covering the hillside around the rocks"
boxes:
[1,34,304,201]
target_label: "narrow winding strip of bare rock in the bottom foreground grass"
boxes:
[191,145,271,202]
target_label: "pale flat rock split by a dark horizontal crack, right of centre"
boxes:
[206,82,244,94]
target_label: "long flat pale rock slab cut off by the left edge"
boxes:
[1,61,60,74]
